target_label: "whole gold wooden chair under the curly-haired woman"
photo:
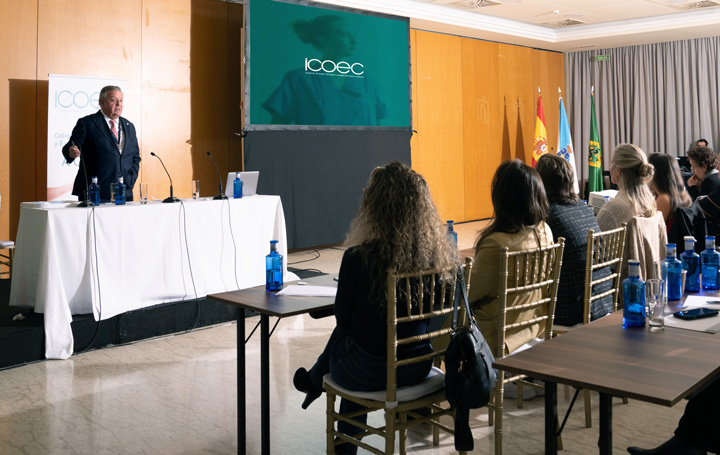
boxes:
[323,258,472,455]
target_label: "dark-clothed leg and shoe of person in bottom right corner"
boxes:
[628,379,720,455]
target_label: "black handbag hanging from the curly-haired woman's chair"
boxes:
[445,275,498,452]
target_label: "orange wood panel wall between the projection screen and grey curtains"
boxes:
[411,30,565,222]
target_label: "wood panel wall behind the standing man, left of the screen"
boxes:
[0,0,243,253]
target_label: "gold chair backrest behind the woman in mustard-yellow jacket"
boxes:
[498,237,565,358]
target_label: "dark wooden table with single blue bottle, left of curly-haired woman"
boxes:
[207,275,337,455]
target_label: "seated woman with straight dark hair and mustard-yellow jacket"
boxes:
[468,160,553,353]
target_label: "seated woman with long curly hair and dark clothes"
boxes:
[293,162,459,453]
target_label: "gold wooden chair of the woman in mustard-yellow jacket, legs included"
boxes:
[488,237,565,455]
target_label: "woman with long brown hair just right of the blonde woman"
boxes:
[648,153,692,232]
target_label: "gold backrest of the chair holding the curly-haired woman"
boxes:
[386,259,472,402]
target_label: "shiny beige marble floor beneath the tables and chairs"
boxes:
[0,223,685,455]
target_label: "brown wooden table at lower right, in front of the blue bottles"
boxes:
[494,311,720,455]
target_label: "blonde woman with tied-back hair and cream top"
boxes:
[597,144,657,231]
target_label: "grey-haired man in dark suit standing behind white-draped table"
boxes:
[62,85,140,201]
